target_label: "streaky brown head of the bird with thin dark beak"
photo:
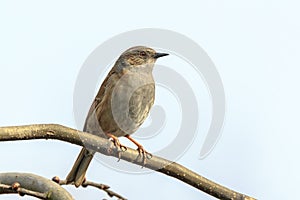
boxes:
[116,46,169,71]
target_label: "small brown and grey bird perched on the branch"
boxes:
[66,46,169,187]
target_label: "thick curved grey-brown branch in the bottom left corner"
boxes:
[0,172,73,200]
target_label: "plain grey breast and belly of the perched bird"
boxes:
[110,73,155,137]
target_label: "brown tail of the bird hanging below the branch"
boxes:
[66,148,95,187]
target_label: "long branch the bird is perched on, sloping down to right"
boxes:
[0,124,254,200]
